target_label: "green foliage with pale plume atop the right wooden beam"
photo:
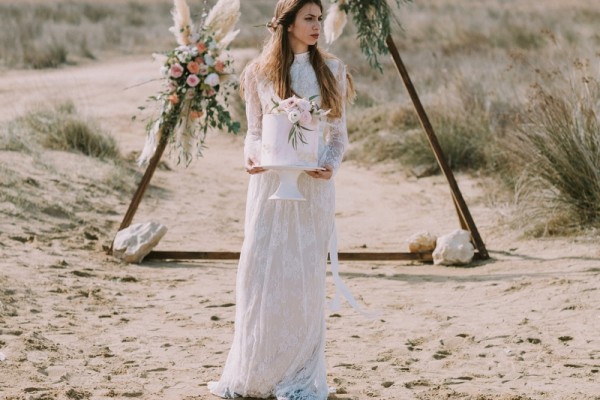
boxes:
[323,0,411,71]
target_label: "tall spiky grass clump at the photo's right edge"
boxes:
[509,68,600,234]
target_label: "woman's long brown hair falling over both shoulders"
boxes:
[240,0,353,118]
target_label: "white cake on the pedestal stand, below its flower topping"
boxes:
[260,113,319,168]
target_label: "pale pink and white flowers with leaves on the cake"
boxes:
[271,95,331,150]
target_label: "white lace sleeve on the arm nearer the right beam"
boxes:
[319,61,348,170]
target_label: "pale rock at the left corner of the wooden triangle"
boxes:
[113,222,167,264]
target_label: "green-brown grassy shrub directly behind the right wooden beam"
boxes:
[349,79,517,173]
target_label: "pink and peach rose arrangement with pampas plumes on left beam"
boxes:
[138,0,240,165]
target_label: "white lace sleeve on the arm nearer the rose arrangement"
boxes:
[244,67,262,167]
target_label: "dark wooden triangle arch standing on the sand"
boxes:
[109,36,489,261]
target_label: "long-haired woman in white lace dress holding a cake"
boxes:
[209,0,353,400]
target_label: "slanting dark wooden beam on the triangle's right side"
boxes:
[386,36,489,259]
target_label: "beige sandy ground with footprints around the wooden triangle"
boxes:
[0,54,600,400]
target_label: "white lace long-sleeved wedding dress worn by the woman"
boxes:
[209,53,348,400]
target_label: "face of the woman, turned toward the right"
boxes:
[288,3,322,54]
